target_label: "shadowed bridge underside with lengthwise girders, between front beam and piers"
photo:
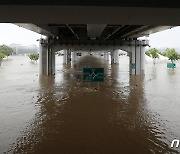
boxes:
[16,23,173,40]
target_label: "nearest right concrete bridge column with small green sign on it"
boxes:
[130,45,145,75]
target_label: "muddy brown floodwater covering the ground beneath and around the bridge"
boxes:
[0,56,180,154]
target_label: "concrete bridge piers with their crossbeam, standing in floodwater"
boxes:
[40,40,145,75]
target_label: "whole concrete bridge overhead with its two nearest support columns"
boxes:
[0,3,180,75]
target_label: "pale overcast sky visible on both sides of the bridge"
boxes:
[0,23,180,48]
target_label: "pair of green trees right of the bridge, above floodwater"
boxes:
[145,48,180,64]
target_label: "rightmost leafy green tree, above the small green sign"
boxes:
[166,48,180,63]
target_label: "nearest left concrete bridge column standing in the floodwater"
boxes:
[39,44,55,75]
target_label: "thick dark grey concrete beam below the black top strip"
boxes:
[0,5,180,26]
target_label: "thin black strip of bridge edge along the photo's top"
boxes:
[0,0,180,8]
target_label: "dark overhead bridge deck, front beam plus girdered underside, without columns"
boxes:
[0,4,177,41]
